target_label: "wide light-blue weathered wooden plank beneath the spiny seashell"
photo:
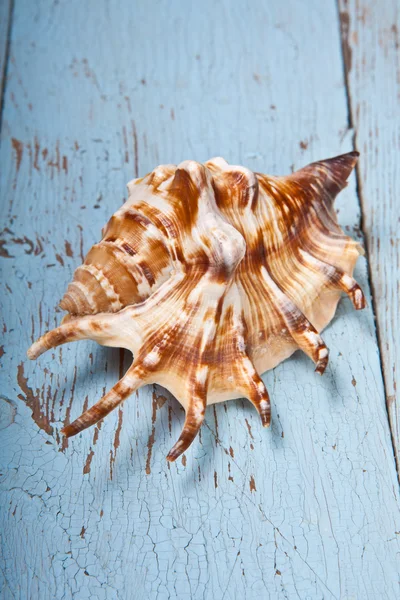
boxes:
[0,0,399,600]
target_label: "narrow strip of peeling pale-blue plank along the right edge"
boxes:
[340,0,400,474]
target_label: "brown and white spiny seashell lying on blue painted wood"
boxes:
[28,152,365,461]
